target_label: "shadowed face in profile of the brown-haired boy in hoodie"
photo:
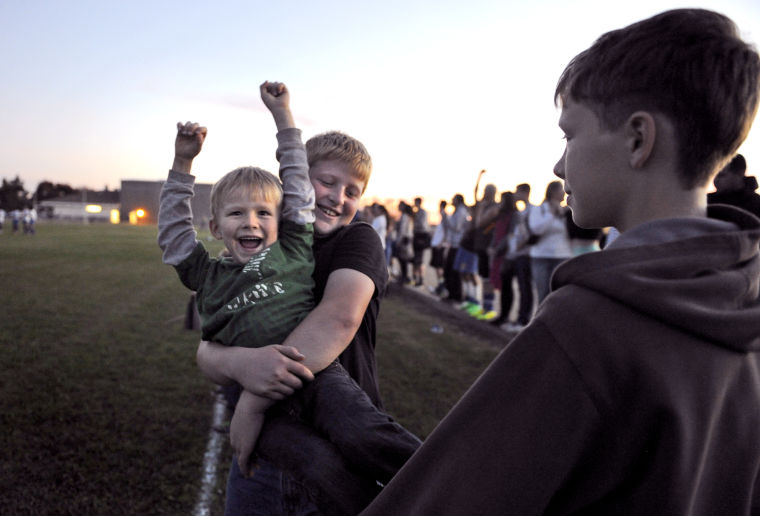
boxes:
[554,99,625,228]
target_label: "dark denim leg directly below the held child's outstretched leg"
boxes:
[254,404,380,515]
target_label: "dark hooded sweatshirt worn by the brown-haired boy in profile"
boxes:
[362,206,760,516]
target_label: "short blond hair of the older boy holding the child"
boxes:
[306,131,372,193]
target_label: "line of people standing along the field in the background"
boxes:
[361,175,606,332]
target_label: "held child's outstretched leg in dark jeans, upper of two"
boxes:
[300,362,422,484]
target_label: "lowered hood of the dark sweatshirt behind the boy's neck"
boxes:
[552,205,760,352]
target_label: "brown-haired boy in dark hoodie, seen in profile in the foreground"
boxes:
[364,9,760,515]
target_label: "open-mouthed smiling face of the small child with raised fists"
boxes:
[209,188,279,264]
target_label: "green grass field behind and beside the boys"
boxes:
[0,224,497,514]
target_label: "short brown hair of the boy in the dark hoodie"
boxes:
[555,9,760,189]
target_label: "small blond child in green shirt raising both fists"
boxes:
[158,82,419,506]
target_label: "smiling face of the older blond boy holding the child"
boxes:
[309,160,365,235]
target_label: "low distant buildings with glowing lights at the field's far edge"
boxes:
[37,180,212,226]
